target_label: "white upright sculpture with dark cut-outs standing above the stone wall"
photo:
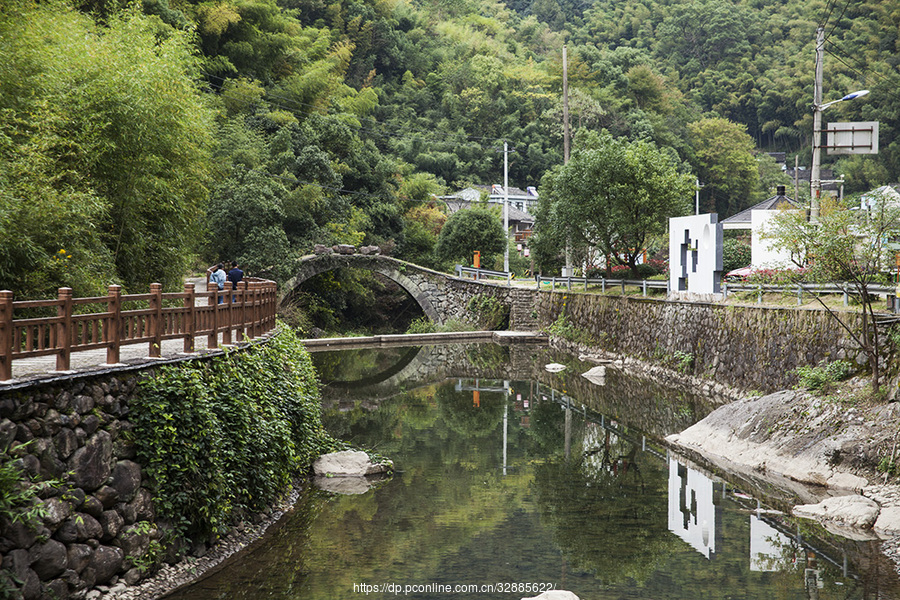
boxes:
[669,214,722,294]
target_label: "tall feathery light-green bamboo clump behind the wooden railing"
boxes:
[0,2,212,289]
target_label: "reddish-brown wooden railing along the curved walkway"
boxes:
[0,278,278,380]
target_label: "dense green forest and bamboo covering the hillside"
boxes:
[0,0,900,298]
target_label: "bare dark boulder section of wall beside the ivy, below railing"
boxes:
[0,373,160,600]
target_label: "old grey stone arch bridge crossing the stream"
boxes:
[285,254,535,329]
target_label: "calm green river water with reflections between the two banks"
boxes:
[163,345,900,600]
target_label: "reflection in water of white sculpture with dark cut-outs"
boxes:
[669,456,721,558]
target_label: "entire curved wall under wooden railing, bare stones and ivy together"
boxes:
[0,329,332,599]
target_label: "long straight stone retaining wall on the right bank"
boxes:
[534,292,880,392]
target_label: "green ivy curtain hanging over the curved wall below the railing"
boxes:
[132,327,333,535]
